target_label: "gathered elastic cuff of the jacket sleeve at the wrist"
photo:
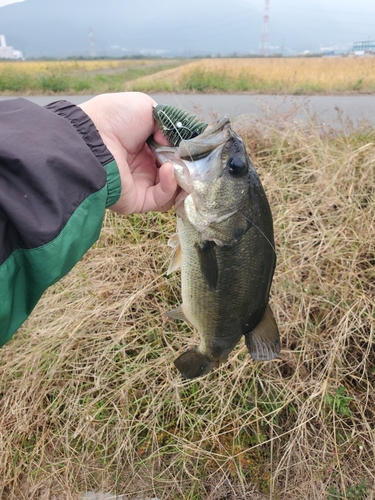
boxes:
[45,100,121,208]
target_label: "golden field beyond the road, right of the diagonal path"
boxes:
[128,57,375,94]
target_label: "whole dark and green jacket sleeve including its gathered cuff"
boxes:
[0,99,121,346]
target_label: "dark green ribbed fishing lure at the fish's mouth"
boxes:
[153,104,208,147]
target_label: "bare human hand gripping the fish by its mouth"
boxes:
[80,92,177,215]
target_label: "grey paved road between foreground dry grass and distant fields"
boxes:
[0,94,375,125]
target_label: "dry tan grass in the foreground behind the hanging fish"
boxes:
[0,110,375,500]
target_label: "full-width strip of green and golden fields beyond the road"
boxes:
[0,57,375,95]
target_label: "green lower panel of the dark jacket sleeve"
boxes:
[0,186,108,346]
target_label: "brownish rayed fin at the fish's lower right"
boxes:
[245,304,280,361]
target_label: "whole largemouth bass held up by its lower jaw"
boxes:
[148,108,280,379]
